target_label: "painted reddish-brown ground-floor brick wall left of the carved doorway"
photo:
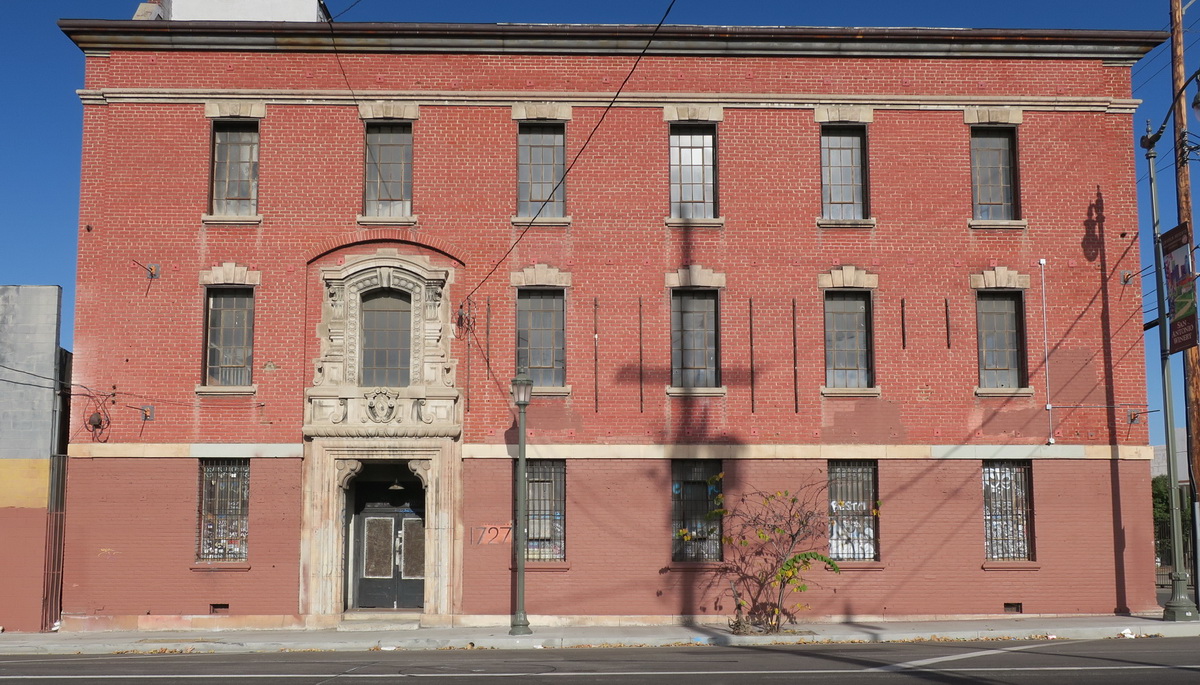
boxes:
[62,457,301,627]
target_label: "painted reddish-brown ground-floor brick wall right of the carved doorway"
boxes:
[463,459,1157,619]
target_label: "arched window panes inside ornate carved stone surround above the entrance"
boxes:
[359,290,413,387]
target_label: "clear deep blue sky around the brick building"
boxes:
[0,0,1200,443]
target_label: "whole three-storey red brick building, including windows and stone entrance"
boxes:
[54,1,1165,630]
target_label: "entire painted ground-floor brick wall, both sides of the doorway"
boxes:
[54,447,1157,630]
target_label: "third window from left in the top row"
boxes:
[517,124,566,217]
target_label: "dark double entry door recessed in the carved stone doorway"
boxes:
[348,475,425,609]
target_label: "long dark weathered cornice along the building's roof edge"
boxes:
[59,19,1169,61]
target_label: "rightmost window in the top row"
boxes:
[971,126,1020,221]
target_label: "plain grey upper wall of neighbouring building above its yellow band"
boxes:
[0,286,62,459]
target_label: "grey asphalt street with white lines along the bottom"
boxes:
[0,637,1200,685]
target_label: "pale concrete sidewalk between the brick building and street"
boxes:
[0,617,1200,655]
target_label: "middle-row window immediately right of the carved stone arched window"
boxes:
[517,288,566,387]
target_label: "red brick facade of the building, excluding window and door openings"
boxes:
[54,22,1164,627]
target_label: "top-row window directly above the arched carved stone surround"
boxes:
[362,121,413,217]
